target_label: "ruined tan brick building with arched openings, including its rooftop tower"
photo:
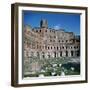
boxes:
[24,20,80,59]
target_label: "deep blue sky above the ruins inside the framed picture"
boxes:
[23,11,80,35]
